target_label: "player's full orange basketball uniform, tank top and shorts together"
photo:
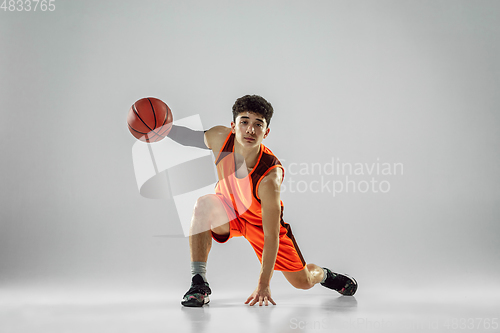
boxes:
[212,133,305,271]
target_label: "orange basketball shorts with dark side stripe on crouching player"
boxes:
[212,194,306,272]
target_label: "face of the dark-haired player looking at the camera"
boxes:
[231,112,269,148]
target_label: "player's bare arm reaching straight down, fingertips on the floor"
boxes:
[246,168,282,305]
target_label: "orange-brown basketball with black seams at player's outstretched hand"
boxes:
[127,97,173,142]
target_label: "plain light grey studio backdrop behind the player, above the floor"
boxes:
[0,0,500,297]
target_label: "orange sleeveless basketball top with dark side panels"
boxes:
[215,133,285,225]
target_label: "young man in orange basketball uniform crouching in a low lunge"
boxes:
[169,95,357,307]
